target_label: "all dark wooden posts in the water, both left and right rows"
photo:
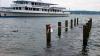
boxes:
[46,18,92,48]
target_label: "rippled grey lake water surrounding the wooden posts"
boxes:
[0,15,100,56]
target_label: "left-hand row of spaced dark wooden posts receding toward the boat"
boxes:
[46,18,79,48]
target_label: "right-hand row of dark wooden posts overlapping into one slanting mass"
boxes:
[83,18,92,47]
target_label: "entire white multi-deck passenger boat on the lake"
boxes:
[0,0,70,16]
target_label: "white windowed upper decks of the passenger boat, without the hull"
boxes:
[0,0,69,14]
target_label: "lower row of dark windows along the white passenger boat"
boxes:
[13,7,61,12]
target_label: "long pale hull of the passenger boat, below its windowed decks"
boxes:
[0,11,69,17]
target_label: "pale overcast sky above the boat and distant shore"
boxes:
[0,0,100,11]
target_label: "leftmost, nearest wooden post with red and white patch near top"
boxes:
[46,24,51,48]
